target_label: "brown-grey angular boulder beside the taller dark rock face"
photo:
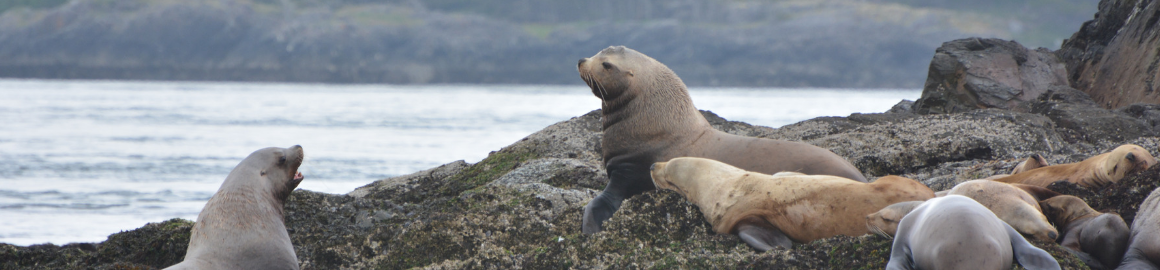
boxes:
[914,38,1068,115]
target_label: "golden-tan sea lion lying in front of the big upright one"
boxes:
[652,158,934,251]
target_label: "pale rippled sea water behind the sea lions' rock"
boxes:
[0,80,920,246]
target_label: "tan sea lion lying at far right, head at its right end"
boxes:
[995,145,1157,188]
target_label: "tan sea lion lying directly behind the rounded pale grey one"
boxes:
[948,180,1059,241]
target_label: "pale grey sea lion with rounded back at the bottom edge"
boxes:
[886,195,1059,270]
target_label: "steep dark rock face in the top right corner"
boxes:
[1056,0,1160,108]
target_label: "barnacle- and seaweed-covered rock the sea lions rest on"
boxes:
[0,95,1160,269]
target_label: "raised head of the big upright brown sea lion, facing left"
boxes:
[577,46,684,102]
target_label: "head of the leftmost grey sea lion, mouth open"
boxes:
[223,145,305,202]
